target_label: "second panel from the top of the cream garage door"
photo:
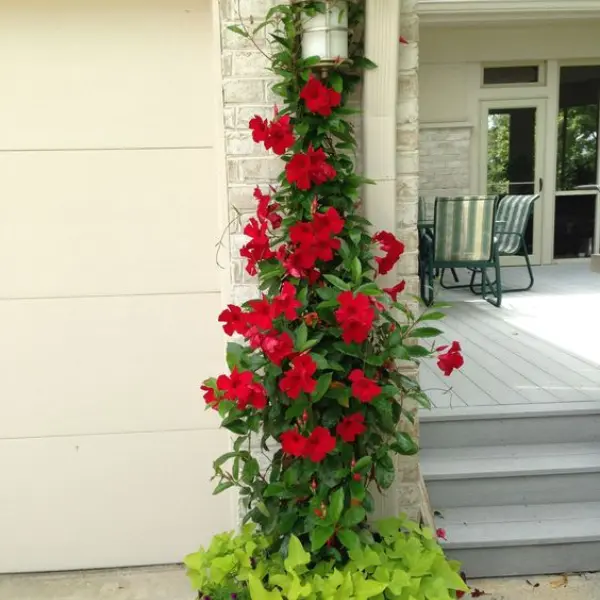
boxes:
[0,150,221,298]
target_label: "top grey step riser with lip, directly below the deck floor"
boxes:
[420,401,600,448]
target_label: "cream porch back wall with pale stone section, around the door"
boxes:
[419,20,600,199]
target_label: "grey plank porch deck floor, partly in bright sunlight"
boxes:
[421,260,600,410]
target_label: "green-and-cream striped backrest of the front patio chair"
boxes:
[434,196,497,263]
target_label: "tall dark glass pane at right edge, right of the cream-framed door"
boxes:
[554,66,600,259]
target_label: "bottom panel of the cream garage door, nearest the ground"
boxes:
[0,431,233,573]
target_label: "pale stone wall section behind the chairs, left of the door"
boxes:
[419,125,472,197]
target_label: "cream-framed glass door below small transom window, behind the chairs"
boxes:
[480,99,546,264]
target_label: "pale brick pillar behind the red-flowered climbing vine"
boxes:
[220,0,426,518]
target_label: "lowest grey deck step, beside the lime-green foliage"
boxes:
[437,502,600,577]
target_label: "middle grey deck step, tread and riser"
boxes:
[421,442,600,509]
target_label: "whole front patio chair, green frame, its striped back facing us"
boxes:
[421,196,502,306]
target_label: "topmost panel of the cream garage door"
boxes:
[0,0,216,149]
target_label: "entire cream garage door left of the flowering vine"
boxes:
[0,0,233,572]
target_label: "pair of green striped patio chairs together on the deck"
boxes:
[418,194,539,307]
